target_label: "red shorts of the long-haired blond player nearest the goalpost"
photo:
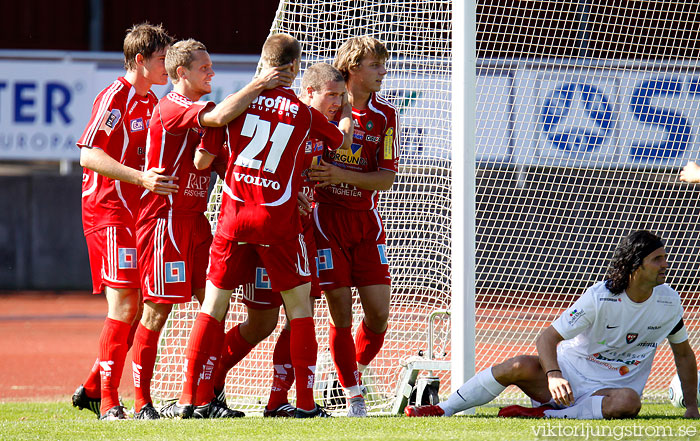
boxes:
[314,204,391,291]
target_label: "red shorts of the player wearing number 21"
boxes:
[207,229,311,294]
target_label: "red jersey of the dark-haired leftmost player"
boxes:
[77,77,158,234]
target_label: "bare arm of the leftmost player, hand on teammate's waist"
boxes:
[80,147,179,195]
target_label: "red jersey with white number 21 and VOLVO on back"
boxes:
[210,88,343,244]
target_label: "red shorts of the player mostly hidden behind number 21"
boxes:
[238,217,323,309]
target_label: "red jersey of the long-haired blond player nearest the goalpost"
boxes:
[315,93,400,210]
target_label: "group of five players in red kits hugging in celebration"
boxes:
[73,24,399,420]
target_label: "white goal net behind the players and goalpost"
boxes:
[153,0,700,411]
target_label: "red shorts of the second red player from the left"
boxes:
[137,214,212,304]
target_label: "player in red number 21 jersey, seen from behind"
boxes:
[167,34,350,418]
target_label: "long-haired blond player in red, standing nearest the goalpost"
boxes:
[309,36,400,416]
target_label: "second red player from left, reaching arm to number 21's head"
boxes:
[133,39,293,419]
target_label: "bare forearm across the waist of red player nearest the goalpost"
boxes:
[309,159,396,191]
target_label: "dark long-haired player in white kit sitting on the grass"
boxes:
[405,231,700,419]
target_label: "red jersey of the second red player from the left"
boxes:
[139,92,214,223]
